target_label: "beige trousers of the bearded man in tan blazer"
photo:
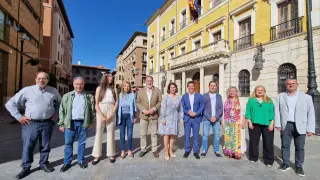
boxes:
[140,119,158,152]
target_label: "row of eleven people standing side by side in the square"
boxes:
[6,72,315,179]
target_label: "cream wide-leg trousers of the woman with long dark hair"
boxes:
[92,103,116,157]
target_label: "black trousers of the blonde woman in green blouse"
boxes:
[249,124,274,165]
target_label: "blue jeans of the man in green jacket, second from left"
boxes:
[64,120,88,164]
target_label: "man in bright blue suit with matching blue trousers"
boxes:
[182,81,204,159]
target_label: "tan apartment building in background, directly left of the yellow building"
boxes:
[115,31,147,87]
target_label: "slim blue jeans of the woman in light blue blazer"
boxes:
[120,114,133,151]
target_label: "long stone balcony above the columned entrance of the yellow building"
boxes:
[169,40,230,70]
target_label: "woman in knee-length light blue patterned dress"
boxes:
[159,83,183,160]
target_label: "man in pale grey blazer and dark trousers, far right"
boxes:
[275,79,315,176]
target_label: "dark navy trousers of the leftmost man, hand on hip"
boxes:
[22,121,55,169]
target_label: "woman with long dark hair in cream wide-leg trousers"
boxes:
[92,74,118,165]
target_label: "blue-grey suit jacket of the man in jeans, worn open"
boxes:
[202,93,223,121]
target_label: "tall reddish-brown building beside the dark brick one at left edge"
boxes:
[40,0,74,94]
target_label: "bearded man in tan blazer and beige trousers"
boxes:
[136,76,162,158]
